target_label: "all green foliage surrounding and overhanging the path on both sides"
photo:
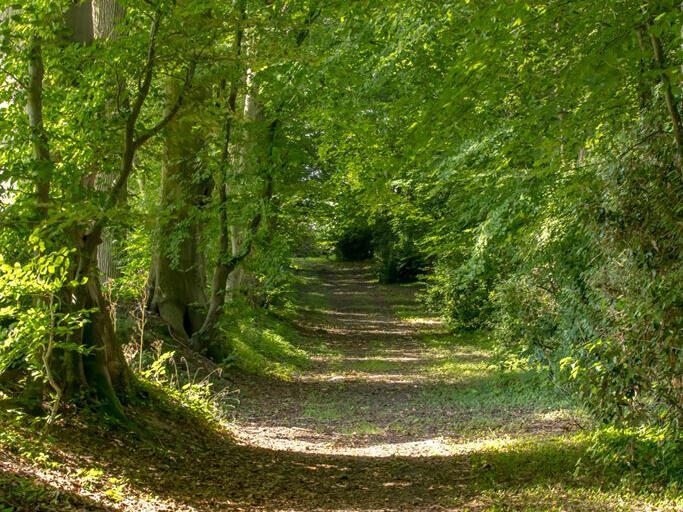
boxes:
[0,0,683,484]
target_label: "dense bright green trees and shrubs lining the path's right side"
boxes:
[306,0,683,436]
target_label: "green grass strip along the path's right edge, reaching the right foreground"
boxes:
[394,278,683,494]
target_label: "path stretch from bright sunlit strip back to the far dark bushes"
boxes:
[232,262,575,457]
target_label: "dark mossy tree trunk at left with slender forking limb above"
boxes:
[36,9,195,421]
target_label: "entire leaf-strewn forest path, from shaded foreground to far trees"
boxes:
[0,261,668,512]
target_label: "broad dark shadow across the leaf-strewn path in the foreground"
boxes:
[14,400,632,512]
